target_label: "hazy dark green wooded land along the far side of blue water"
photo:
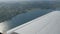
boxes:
[0,2,60,22]
